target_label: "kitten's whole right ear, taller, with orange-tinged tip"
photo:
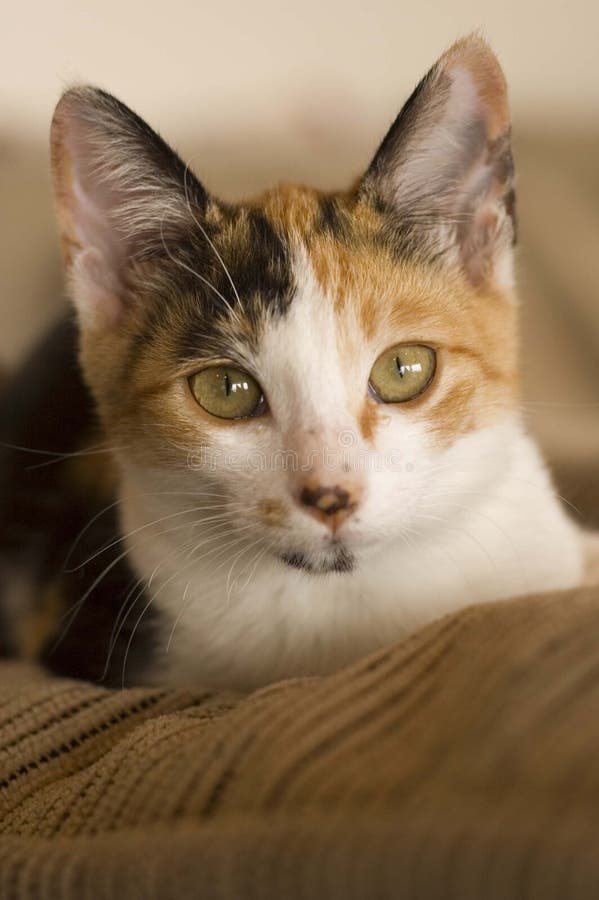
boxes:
[363,36,516,287]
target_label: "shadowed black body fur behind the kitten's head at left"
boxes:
[0,318,162,685]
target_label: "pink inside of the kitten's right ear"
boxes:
[395,41,513,287]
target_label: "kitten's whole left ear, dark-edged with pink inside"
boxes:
[51,87,208,327]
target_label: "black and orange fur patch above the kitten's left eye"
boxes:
[124,207,295,374]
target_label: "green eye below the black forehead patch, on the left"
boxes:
[189,364,266,419]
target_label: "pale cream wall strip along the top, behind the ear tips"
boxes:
[0,0,599,142]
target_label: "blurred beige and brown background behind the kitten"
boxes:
[0,0,599,524]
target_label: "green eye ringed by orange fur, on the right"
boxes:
[370,344,437,403]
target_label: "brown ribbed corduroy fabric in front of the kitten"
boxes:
[0,588,599,900]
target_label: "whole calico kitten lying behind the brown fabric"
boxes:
[0,37,582,689]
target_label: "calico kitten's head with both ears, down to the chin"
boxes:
[52,37,517,574]
